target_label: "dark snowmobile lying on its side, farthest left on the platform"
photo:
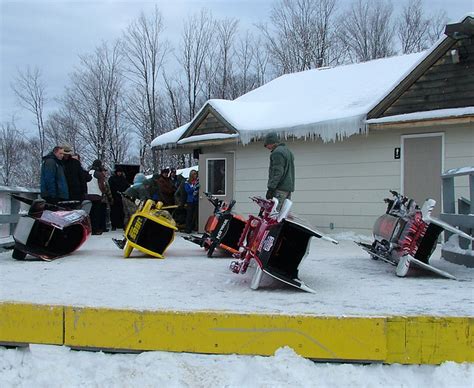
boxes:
[12,194,91,261]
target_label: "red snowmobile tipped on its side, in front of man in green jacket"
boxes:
[230,197,338,293]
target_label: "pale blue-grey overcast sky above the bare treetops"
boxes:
[0,0,474,136]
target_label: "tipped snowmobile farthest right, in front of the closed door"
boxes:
[356,190,473,279]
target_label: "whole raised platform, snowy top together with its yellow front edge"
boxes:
[0,232,474,364]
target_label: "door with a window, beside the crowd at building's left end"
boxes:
[198,152,234,232]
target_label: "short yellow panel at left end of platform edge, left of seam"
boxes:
[0,303,64,345]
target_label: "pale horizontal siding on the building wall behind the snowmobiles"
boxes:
[230,125,474,235]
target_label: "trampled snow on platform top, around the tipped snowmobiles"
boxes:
[0,232,474,316]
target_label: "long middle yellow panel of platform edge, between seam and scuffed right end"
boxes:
[65,307,386,361]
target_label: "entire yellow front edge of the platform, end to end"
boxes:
[0,303,474,364]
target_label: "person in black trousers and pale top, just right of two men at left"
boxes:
[87,159,107,235]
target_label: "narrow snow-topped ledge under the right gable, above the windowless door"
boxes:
[365,106,474,129]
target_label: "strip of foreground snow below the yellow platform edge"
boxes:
[0,345,474,388]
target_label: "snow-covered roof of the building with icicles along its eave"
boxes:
[151,14,472,147]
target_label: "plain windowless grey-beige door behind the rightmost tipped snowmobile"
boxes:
[402,134,443,217]
